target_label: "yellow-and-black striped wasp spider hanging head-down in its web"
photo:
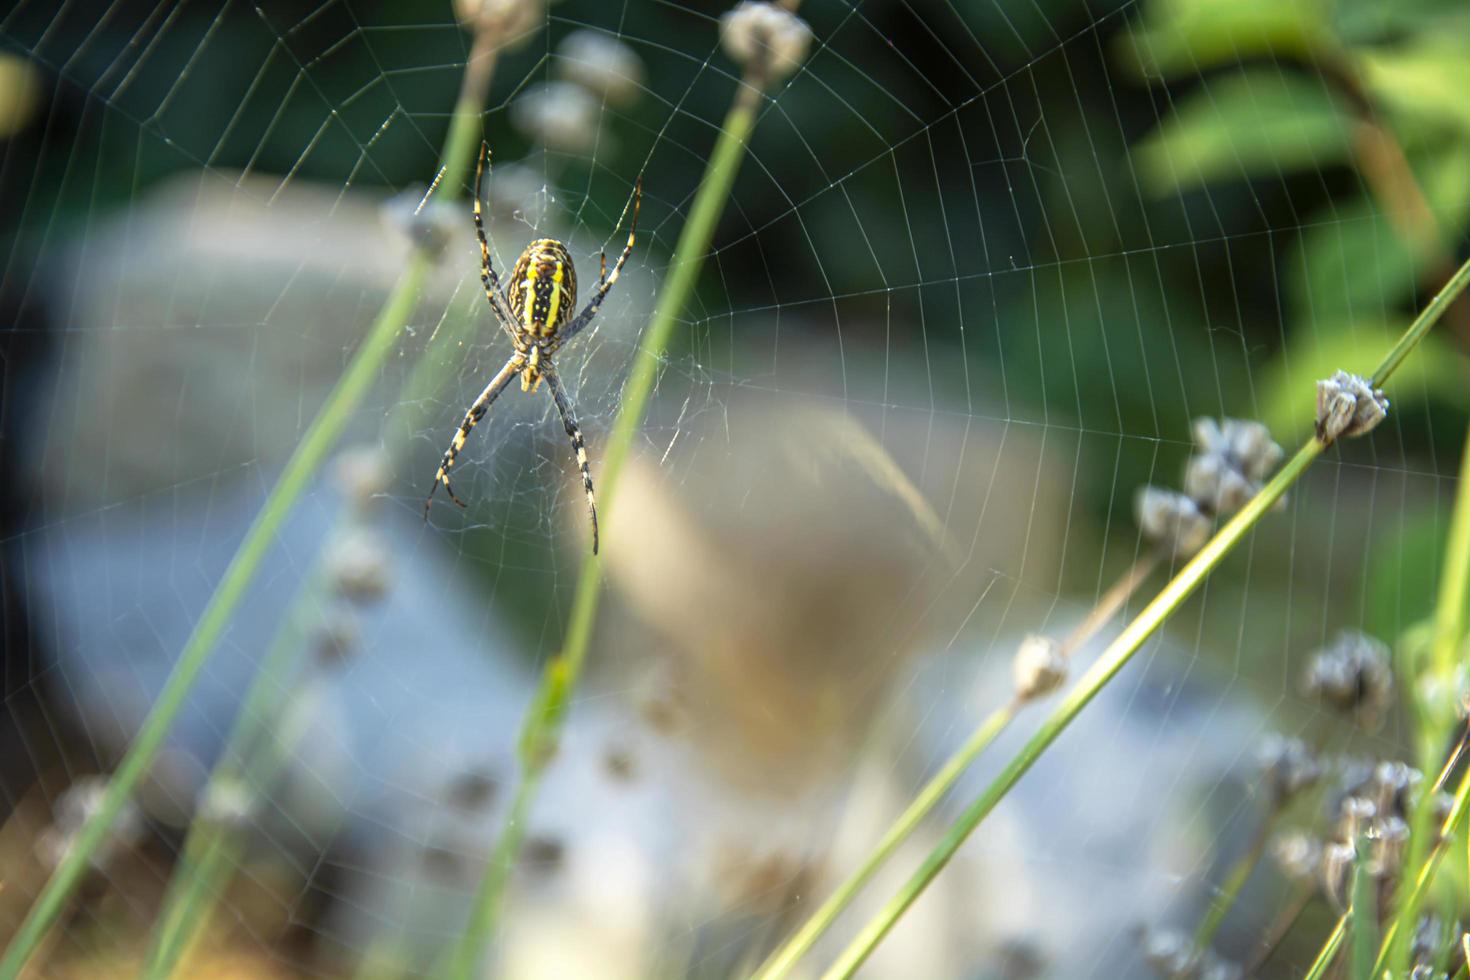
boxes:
[423,144,642,554]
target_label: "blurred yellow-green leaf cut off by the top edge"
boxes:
[1114,0,1335,78]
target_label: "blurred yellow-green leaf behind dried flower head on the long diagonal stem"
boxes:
[1260,322,1470,445]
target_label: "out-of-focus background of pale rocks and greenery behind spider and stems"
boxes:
[0,0,1470,977]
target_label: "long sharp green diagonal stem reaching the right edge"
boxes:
[823,255,1470,979]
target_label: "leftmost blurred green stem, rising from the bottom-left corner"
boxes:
[0,30,499,980]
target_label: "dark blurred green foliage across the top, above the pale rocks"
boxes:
[0,0,1470,643]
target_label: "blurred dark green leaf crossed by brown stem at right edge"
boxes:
[1285,141,1470,323]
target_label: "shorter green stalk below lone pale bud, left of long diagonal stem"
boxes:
[754,699,1022,980]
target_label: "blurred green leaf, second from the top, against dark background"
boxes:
[1133,69,1352,195]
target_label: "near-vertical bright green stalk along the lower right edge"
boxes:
[1386,429,1470,977]
